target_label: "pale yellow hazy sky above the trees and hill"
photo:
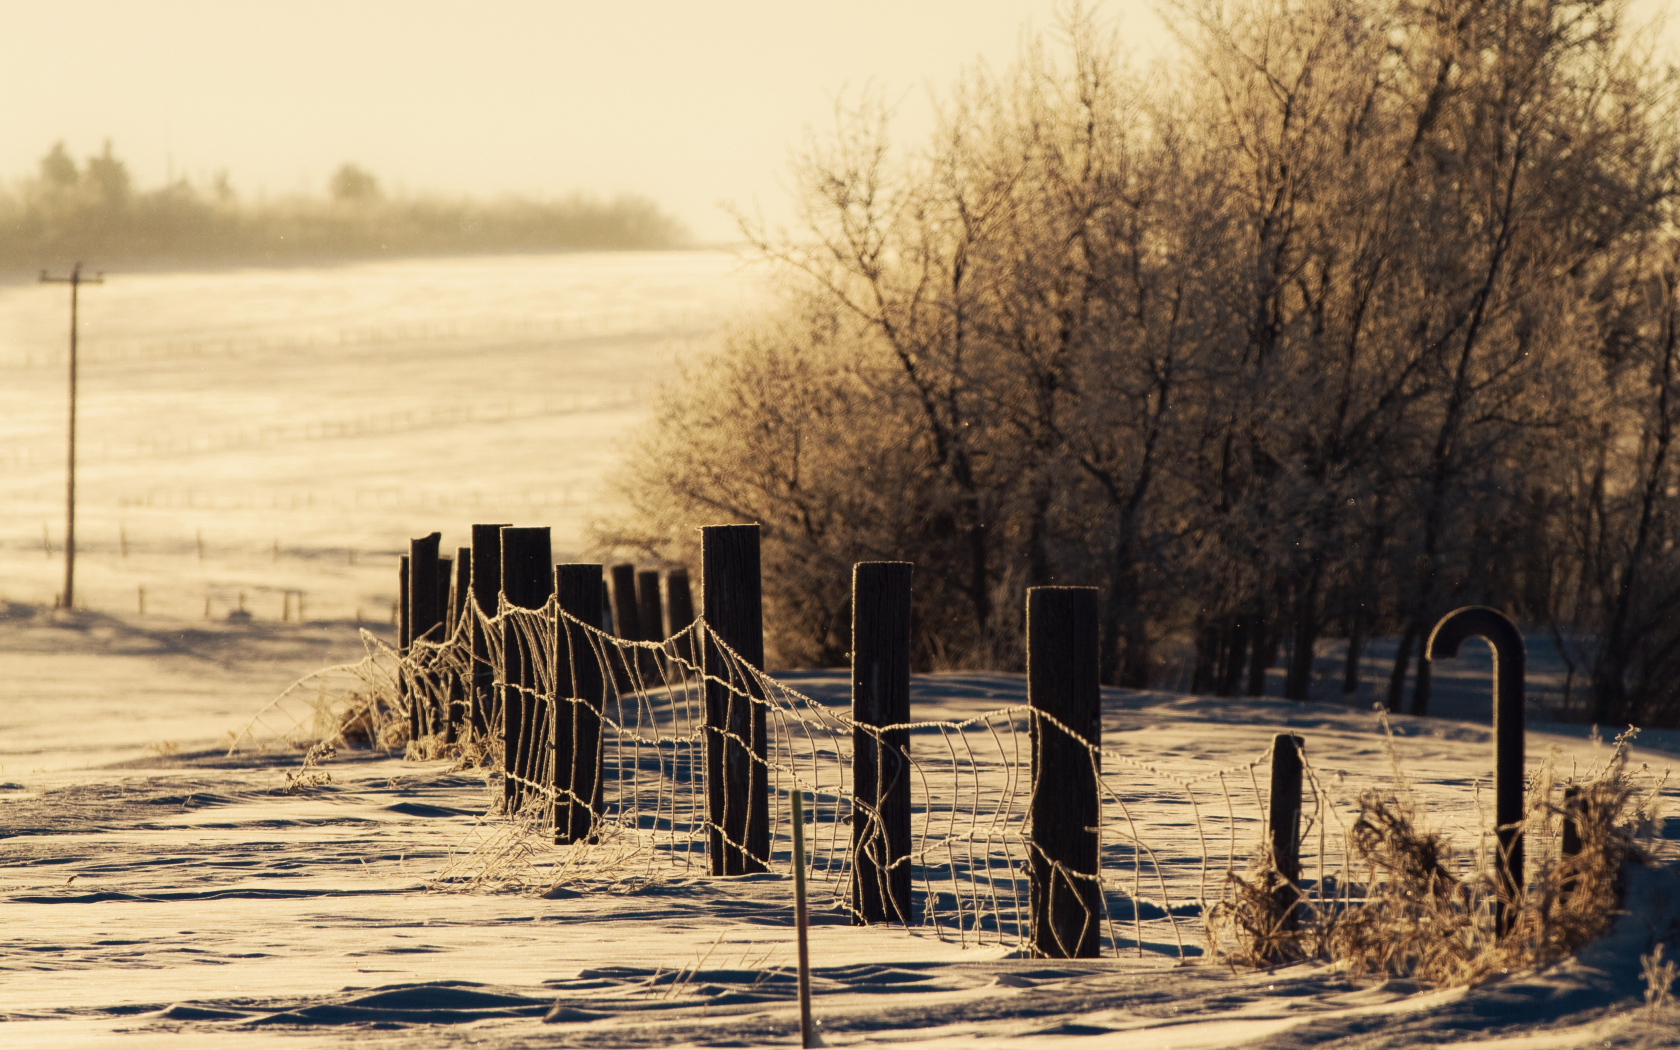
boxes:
[0,0,1663,240]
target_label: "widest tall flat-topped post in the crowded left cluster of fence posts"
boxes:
[502,526,554,811]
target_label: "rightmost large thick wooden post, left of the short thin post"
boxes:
[1026,586,1102,959]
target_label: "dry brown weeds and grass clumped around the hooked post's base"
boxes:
[1208,731,1662,986]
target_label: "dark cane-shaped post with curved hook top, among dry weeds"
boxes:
[1423,605,1529,934]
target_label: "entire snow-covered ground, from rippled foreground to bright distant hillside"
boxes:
[0,254,1680,1050]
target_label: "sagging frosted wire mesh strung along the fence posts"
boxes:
[232,598,1391,956]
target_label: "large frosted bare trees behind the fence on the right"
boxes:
[601,0,1680,726]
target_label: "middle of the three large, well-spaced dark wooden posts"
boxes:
[852,561,914,926]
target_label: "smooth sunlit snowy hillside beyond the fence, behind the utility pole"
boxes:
[0,252,753,623]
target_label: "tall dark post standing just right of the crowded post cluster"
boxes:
[701,524,769,875]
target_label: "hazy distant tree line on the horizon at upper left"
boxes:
[0,143,687,272]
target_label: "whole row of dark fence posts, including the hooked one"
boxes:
[400,524,1545,958]
